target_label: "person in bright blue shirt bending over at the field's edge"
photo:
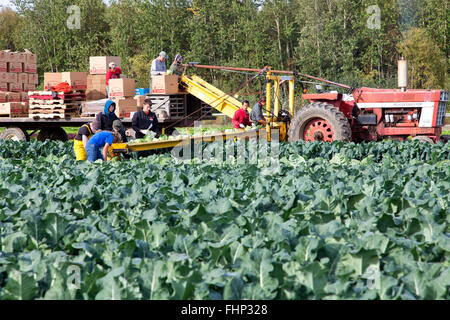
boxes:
[86,120,122,162]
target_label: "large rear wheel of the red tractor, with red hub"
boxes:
[288,102,352,142]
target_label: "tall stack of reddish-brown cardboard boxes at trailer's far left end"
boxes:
[0,50,39,117]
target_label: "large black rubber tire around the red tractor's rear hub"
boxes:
[288,102,352,142]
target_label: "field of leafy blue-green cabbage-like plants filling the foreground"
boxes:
[0,141,450,300]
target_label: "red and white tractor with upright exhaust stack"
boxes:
[288,61,449,143]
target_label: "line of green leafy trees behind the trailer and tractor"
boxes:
[0,0,450,91]
